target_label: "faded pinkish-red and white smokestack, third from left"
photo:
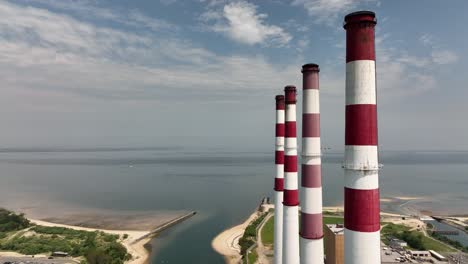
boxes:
[300,64,323,264]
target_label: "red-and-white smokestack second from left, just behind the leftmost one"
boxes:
[283,86,299,264]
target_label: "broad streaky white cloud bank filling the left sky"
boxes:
[0,2,298,101]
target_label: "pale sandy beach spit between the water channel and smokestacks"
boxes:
[211,211,259,264]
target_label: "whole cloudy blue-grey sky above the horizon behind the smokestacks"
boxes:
[0,0,468,151]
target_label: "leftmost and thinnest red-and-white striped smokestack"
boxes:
[273,95,285,264]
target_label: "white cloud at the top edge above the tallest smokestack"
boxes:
[292,0,378,24]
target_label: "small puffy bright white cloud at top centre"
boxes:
[201,1,292,46]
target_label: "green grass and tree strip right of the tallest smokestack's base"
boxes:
[381,223,454,252]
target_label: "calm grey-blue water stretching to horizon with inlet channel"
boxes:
[0,148,468,263]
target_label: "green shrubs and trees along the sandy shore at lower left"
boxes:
[0,209,131,264]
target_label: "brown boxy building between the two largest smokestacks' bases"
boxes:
[324,224,344,264]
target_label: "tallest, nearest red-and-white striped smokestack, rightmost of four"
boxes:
[343,11,380,264]
